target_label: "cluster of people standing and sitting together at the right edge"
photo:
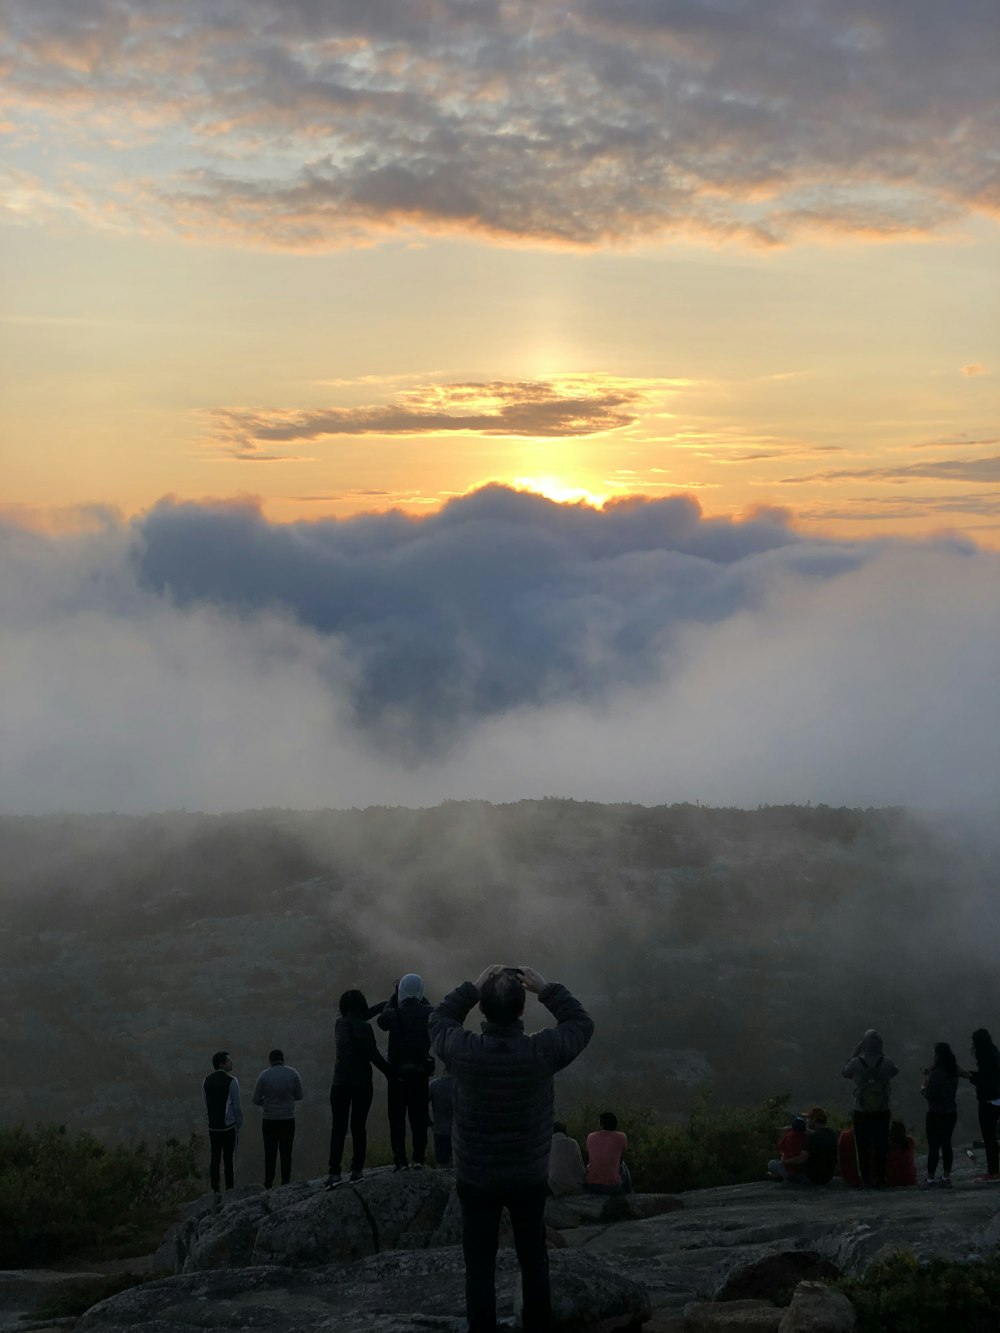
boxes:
[768,1028,1000,1189]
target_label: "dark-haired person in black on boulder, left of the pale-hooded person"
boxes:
[327,990,389,1189]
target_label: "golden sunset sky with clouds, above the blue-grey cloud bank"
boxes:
[0,0,1000,547]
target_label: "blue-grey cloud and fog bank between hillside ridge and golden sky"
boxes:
[0,487,1000,812]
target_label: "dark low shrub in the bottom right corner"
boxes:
[833,1252,1000,1333]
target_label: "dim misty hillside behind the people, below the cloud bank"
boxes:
[0,800,1000,1172]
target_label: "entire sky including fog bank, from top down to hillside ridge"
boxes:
[0,0,1000,812]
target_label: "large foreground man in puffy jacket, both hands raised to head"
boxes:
[431,964,593,1333]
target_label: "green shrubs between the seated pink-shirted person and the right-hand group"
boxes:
[569,1090,789,1194]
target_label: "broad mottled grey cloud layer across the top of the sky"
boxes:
[5,0,1000,249]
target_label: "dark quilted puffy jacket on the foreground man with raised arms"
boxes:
[431,981,593,1189]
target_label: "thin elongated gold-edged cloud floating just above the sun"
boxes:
[207,379,653,461]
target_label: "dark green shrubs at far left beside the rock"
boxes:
[0,1125,199,1268]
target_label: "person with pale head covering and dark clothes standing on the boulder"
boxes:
[379,972,433,1170]
